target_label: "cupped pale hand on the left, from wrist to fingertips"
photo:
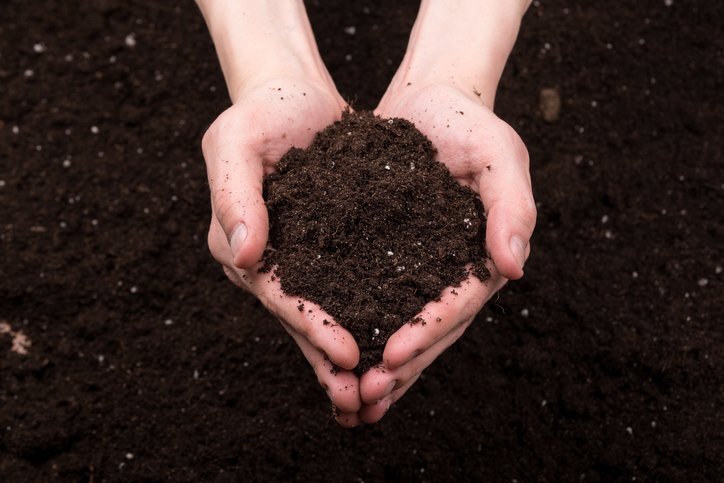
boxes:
[202,77,361,426]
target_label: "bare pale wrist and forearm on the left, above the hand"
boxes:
[196,0,336,102]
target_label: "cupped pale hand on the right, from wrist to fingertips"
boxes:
[360,81,536,422]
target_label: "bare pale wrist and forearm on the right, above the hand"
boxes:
[383,0,530,109]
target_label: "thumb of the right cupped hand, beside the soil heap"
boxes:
[477,125,536,280]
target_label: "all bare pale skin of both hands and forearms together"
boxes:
[197,0,536,427]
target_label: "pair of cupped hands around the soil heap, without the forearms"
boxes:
[202,69,536,427]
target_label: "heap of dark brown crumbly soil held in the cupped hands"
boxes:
[262,112,490,374]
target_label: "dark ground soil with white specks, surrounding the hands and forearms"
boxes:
[0,0,724,482]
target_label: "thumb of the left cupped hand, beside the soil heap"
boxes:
[202,131,269,268]
